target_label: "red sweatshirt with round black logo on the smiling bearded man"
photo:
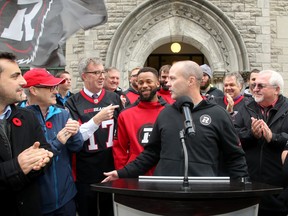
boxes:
[113,97,166,175]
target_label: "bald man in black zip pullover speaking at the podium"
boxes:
[103,61,248,182]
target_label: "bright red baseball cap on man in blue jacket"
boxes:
[23,68,65,88]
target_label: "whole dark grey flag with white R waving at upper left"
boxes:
[0,0,107,67]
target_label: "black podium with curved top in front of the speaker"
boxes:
[91,179,283,216]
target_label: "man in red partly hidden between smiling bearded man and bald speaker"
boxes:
[157,65,175,104]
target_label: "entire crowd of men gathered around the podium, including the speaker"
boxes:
[0,52,288,216]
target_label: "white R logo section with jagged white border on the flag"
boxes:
[0,0,53,64]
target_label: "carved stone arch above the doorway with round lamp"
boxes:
[106,0,249,88]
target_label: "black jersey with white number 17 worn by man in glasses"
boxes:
[65,89,122,183]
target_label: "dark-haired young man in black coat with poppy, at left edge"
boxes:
[0,52,53,216]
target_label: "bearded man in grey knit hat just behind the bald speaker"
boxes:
[200,64,224,98]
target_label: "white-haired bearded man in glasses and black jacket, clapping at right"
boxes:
[234,70,288,216]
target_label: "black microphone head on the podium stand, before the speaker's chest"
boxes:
[175,96,195,136]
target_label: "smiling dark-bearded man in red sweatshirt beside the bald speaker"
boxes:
[113,67,166,175]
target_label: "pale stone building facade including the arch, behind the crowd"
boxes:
[66,0,288,95]
